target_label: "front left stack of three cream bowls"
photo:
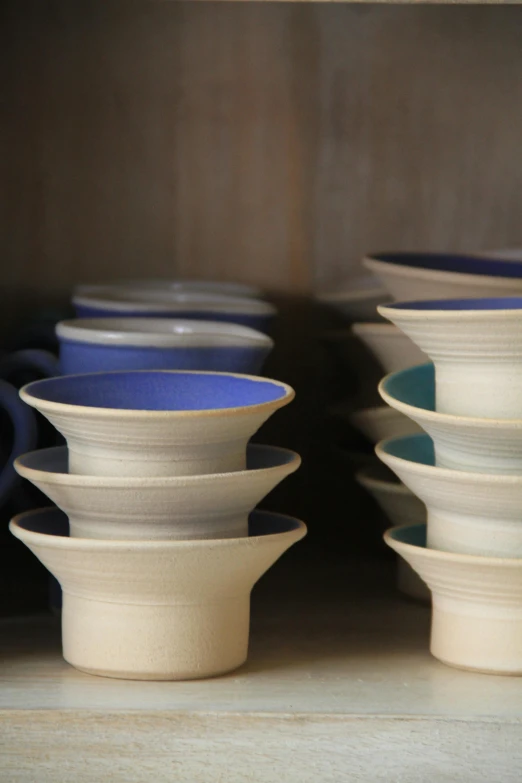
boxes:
[11,371,306,680]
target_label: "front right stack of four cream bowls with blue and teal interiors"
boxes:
[377,297,522,674]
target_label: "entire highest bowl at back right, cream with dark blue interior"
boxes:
[363,253,522,301]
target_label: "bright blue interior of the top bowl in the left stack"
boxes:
[25,371,288,411]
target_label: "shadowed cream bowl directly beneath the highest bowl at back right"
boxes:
[351,324,428,373]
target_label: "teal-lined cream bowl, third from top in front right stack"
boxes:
[376,434,522,557]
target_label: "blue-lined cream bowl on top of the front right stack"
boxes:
[379,297,522,419]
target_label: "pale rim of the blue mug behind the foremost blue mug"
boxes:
[72,286,277,320]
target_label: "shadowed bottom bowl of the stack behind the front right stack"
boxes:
[355,465,430,601]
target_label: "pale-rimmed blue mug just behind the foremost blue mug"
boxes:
[73,286,277,332]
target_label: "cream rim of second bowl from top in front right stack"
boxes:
[377,362,522,432]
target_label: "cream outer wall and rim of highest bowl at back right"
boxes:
[362,253,522,301]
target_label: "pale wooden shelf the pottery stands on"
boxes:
[0,563,522,783]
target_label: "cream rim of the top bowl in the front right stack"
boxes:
[377,296,522,321]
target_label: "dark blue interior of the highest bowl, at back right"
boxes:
[371,253,522,278]
